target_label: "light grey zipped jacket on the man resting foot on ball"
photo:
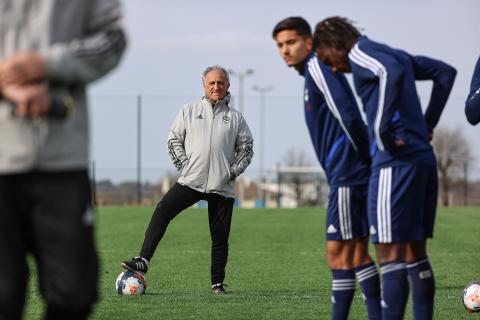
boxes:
[167,93,253,198]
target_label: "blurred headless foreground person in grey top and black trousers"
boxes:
[0,0,126,319]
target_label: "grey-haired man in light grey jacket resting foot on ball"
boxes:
[122,65,253,294]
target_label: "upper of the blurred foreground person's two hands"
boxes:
[0,52,47,88]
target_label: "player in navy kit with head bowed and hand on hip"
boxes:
[314,17,456,319]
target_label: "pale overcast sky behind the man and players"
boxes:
[90,0,480,180]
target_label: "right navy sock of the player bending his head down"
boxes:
[407,258,435,320]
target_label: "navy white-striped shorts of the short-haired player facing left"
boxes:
[326,184,368,241]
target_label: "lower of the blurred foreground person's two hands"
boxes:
[1,84,51,118]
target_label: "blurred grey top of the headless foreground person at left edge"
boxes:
[0,0,126,174]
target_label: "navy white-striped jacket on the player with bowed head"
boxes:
[348,36,456,167]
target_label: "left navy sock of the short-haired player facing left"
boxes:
[332,269,355,320]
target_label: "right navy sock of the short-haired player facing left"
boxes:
[355,262,382,320]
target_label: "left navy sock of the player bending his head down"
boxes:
[380,261,409,320]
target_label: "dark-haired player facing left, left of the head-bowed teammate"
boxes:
[272,17,380,320]
